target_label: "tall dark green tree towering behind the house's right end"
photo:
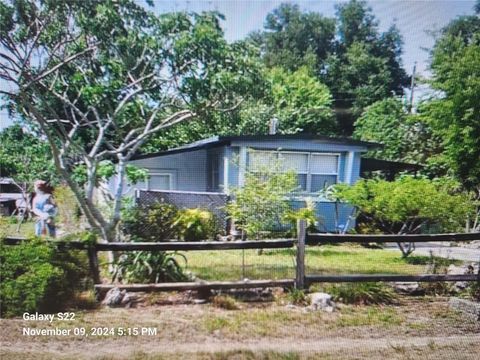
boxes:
[322,0,409,129]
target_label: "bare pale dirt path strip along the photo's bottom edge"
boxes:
[2,335,480,360]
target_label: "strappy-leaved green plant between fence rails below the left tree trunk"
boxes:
[112,251,188,283]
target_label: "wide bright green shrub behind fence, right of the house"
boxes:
[335,176,474,234]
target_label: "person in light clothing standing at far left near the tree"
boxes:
[32,180,57,237]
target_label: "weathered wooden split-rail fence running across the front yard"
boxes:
[3,220,480,293]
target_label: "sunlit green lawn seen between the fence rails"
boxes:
[180,244,455,281]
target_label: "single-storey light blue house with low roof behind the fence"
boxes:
[123,134,378,232]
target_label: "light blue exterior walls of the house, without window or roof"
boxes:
[125,140,366,232]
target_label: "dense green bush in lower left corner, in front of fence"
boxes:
[0,239,88,316]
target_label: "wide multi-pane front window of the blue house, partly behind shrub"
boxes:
[248,150,339,192]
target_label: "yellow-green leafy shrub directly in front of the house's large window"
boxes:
[226,164,297,239]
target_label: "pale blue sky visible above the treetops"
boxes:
[0,0,475,129]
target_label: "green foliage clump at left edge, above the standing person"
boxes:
[0,124,58,186]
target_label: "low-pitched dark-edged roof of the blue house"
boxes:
[132,134,381,160]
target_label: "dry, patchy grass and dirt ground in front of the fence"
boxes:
[0,294,480,360]
